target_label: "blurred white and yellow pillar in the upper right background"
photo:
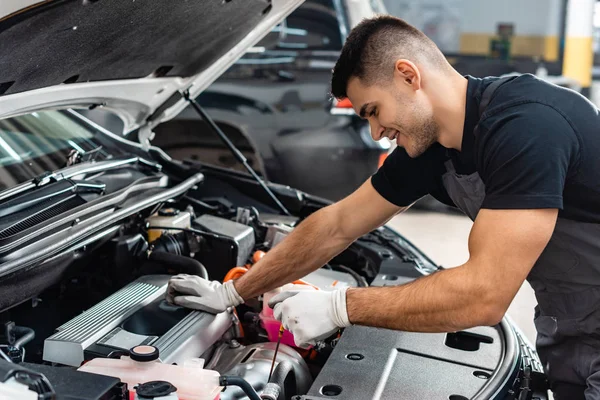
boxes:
[563,0,596,96]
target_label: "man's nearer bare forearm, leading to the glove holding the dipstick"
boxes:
[346,265,503,332]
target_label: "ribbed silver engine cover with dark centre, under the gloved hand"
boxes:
[44,275,231,367]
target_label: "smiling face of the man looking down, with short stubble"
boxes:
[347,78,439,158]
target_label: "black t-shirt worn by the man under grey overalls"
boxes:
[372,74,600,223]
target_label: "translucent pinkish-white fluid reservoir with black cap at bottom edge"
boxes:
[79,346,223,400]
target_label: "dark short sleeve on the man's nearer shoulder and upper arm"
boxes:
[477,103,579,209]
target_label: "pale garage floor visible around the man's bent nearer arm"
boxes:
[389,210,536,344]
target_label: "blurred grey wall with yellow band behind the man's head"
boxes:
[385,0,564,61]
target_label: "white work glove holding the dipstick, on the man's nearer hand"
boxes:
[269,288,351,348]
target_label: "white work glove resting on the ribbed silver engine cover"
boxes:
[167,274,244,314]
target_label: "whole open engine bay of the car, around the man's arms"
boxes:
[0,160,541,400]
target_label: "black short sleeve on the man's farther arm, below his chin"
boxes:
[371,144,445,207]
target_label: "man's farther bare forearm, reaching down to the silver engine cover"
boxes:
[235,208,353,299]
